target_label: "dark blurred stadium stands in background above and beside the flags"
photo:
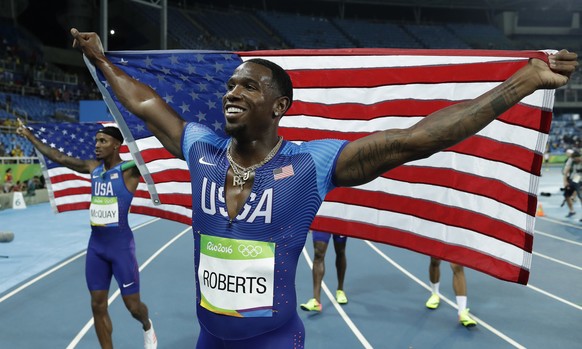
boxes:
[0,0,582,163]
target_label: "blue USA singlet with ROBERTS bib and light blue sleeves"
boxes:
[182,123,346,342]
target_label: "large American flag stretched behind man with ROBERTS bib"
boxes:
[43,49,553,284]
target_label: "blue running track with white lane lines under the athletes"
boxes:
[0,168,582,349]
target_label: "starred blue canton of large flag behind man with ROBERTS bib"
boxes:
[97,51,242,139]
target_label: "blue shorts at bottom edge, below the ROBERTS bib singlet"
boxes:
[196,313,305,349]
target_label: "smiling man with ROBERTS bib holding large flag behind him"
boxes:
[71,29,578,349]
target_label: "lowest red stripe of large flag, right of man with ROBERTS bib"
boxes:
[312,216,529,285]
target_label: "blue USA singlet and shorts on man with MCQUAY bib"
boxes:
[85,163,139,295]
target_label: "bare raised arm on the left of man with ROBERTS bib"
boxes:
[71,28,186,159]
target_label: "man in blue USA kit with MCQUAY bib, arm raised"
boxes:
[16,120,157,349]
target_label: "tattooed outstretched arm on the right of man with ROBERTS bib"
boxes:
[335,50,578,186]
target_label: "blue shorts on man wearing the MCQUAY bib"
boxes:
[85,235,139,296]
